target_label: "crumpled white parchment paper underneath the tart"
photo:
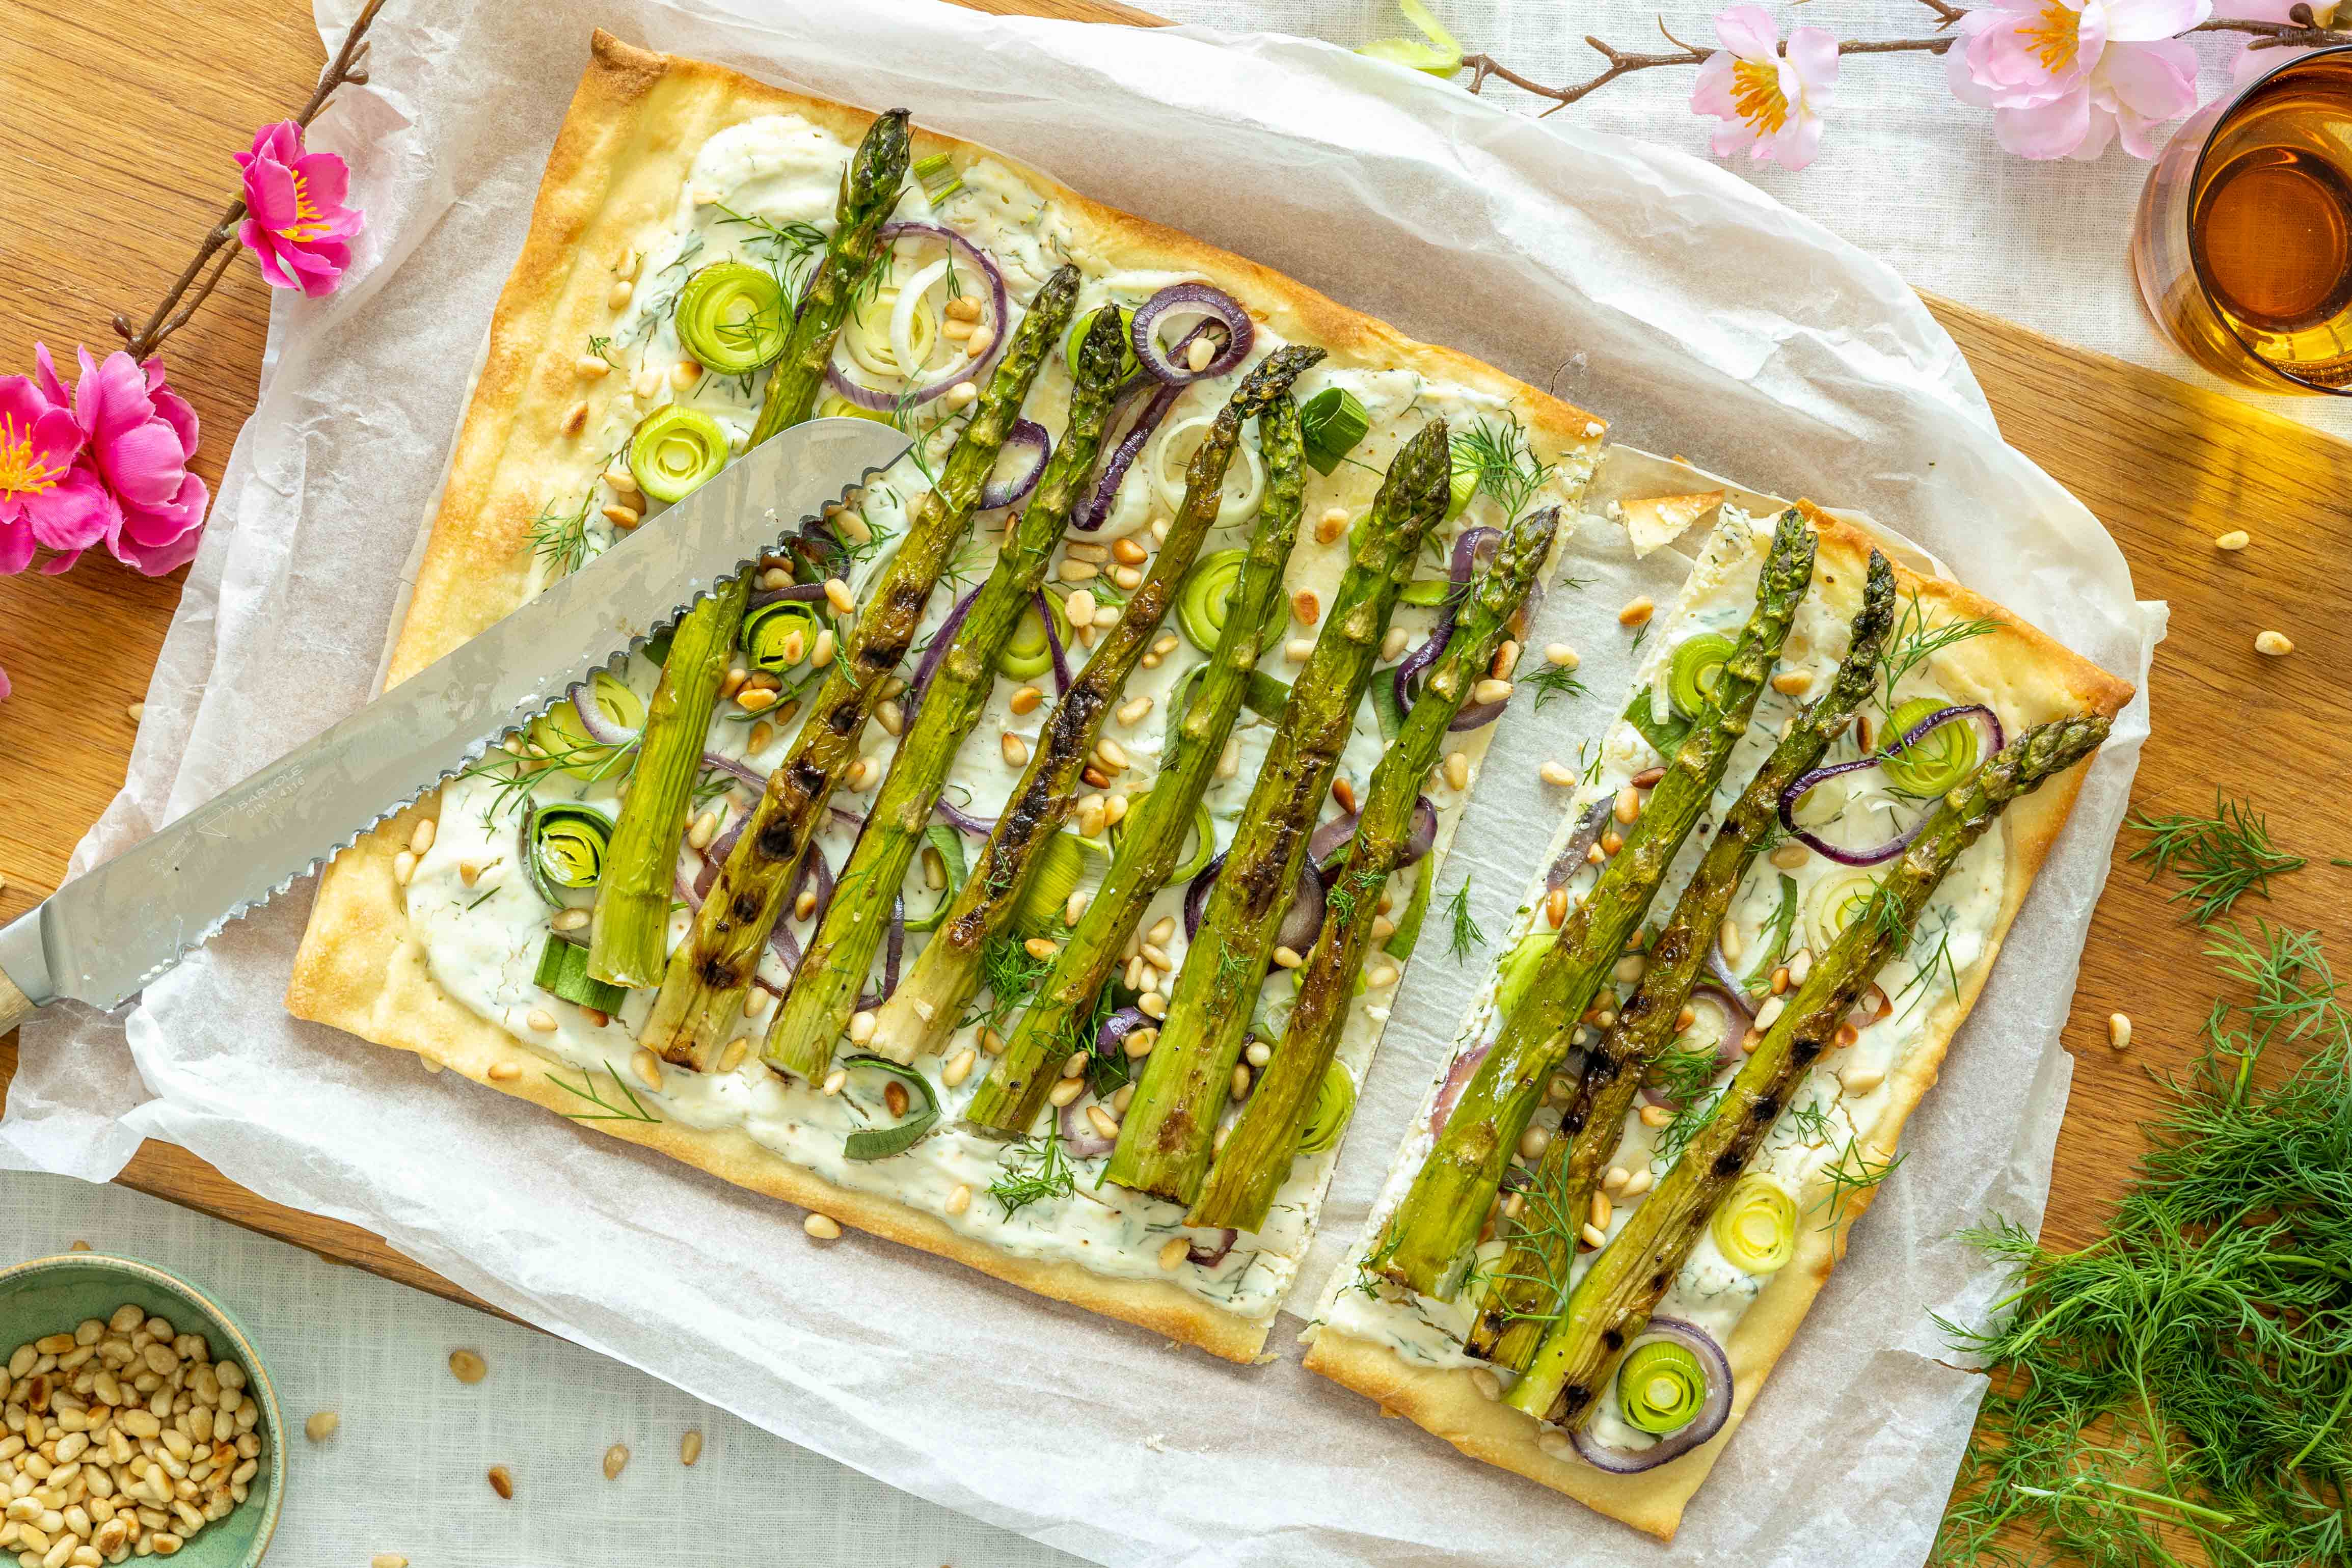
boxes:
[0,0,2161,1568]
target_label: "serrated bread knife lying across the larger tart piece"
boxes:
[0,418,908,1032]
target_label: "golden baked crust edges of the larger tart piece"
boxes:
[287,31,1600,1361]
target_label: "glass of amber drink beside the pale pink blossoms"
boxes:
[2131,45,2352,395]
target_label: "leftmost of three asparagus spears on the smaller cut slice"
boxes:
[1371,508,1816,1300]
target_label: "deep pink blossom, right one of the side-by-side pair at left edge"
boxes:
[48,348,212,576]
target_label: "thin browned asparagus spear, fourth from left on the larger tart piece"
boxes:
[875,345,1324,1063]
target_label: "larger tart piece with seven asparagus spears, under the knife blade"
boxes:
[287,33,1599,1361]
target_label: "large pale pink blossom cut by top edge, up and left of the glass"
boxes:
[1943,0,2213,157]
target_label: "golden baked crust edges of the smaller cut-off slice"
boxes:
[1305,501,2131,1540]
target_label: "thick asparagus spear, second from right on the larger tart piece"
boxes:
[1110,418,1451,1204]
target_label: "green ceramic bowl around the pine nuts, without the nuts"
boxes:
[0,1253,287,1568]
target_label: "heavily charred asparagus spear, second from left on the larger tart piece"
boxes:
[637,265,1077,1072]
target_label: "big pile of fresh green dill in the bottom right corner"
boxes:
[1933,924,2352,1568]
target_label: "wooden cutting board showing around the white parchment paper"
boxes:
[0,0,2352,1476]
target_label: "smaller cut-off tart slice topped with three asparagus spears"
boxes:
[1305,494,2131,1537]
